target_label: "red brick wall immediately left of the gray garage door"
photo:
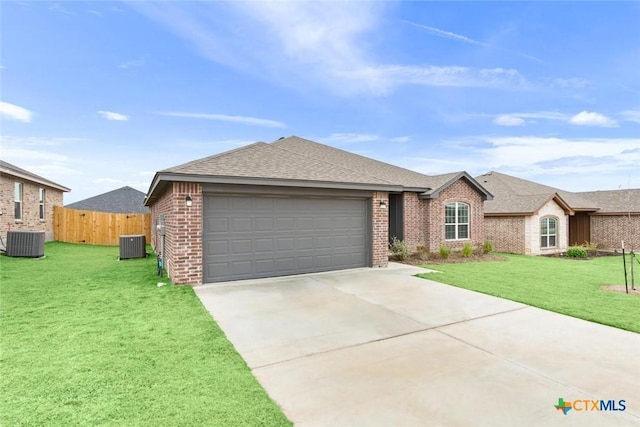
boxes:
[151,182,202,285]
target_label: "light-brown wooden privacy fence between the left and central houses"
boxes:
[53,206,151,246]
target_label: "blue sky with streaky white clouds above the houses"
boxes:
[0,1,640,203]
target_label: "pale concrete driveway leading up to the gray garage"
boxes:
[196,264,640,427]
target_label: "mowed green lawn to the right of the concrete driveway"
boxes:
[419,255,640,332]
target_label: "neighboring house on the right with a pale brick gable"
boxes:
[476,172,640,255]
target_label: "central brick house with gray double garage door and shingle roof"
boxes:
[145,136,491,284]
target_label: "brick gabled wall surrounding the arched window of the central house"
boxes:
[424,179,485,251]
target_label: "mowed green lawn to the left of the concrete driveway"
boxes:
[0,242,291,426]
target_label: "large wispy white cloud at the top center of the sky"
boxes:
[132,2,528,96]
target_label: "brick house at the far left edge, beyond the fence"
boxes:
[0,160,71,243]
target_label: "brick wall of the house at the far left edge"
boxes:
[0,175,64,243]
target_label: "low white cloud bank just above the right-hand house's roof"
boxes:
[408,136,640,191]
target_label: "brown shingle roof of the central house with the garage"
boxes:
[147,136,491,203]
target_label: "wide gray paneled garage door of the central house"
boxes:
[203,196,370,283]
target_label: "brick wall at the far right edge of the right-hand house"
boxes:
[591,214,640,252]
